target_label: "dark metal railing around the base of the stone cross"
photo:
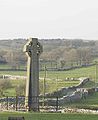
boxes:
[0,96,61,112]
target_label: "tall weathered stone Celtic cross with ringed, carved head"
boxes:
[24,38,43,111]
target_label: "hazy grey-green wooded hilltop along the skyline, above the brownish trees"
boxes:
[0,39,96,51]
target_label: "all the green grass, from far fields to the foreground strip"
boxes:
[0,66,98,117]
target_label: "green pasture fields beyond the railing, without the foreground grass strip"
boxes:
[0,66,98,109]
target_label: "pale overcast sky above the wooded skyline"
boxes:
[0,0,98,40]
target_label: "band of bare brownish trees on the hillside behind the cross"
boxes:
[0,39,98,69]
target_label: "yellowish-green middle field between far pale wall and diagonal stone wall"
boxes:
[2,80,79,96]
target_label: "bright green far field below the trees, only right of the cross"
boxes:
[40,66,95,80]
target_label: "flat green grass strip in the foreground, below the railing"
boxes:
[0,112,98,120]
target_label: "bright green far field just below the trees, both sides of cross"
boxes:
[0,66,96,80]
